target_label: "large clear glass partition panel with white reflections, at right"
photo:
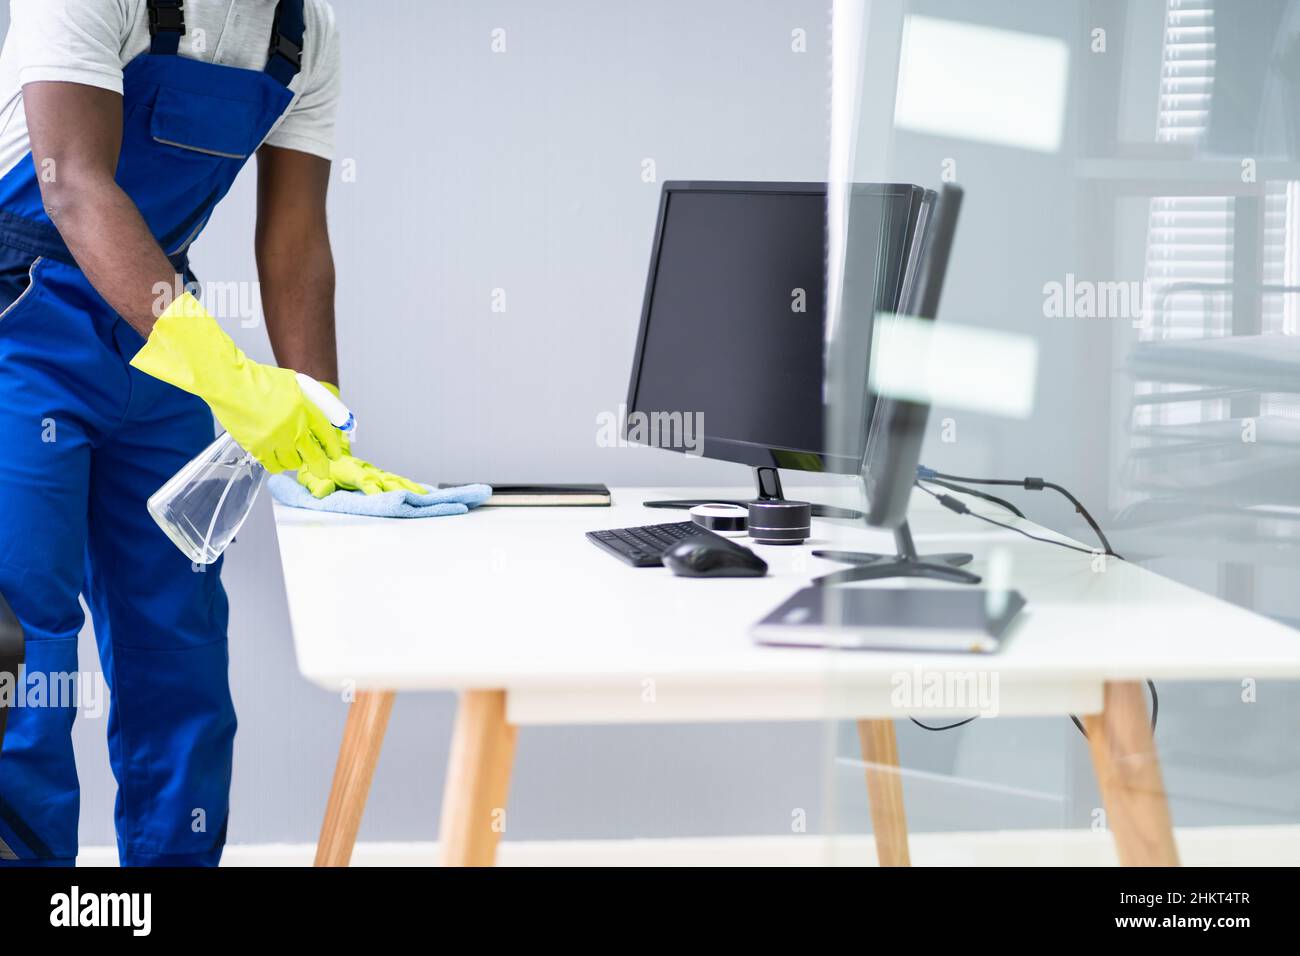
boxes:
[811,0,1300,864]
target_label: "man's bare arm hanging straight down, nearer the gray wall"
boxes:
[256,146,338,385]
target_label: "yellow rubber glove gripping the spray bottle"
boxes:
[131,293,343,477]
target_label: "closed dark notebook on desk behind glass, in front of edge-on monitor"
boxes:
[751,588,1024,654]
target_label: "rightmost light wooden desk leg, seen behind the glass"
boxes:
[1083,680,1178,866]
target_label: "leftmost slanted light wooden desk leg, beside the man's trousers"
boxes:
[316,691,397,866]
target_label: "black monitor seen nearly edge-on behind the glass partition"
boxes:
[813,179,980,585]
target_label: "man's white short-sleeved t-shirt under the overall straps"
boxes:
[0,0,341,176]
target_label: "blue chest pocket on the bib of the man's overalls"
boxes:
[150,87,267,160]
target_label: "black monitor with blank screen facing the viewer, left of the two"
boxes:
[627,182,926,516]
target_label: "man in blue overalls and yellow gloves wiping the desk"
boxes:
[0,0,411,865]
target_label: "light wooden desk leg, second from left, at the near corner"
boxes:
[439,691,517,866]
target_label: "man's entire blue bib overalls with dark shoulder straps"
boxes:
[0,0,306,866]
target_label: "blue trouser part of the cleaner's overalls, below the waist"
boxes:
[0,250,235,866]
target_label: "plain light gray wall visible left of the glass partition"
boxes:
[55,0,828,845]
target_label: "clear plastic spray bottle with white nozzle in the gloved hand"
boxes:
[148,372,356,564]
